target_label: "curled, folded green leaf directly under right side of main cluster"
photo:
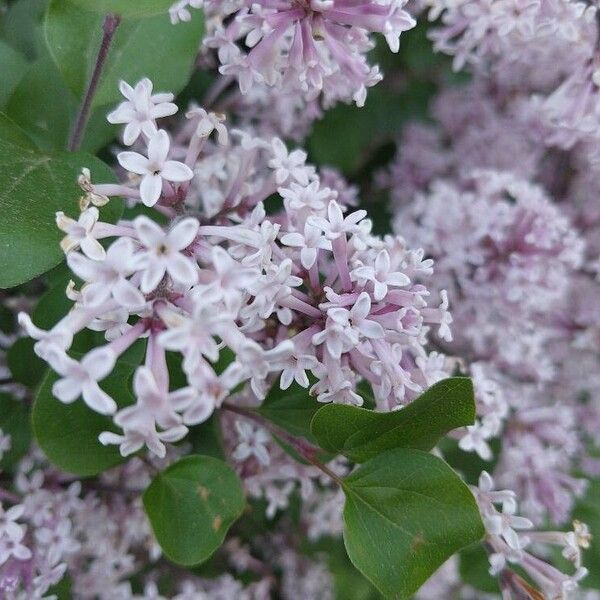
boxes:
[311,377,475,462]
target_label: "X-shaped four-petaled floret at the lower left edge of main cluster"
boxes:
[46,347,117,415]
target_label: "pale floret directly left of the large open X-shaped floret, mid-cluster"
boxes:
[67,238,145,308]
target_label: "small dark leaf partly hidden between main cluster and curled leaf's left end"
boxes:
[257,381,321,443]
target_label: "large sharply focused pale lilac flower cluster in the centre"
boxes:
[19,81,451,456]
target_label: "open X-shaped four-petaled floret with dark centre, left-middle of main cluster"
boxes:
[133,216,198,294]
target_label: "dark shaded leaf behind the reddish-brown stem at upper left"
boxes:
[6,56,118,153]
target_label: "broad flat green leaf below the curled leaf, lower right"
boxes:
[342,448,484,600]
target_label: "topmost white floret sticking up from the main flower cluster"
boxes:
[106,78,177,146]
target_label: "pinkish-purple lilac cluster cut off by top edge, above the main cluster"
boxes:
[171,0,415,106]
